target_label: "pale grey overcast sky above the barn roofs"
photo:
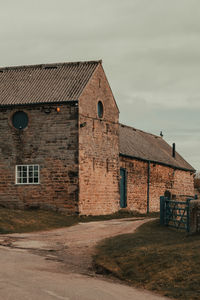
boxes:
[0,0,200,170]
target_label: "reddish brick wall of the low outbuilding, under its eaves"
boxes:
[120,156,194,212]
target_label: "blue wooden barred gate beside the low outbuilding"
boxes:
[160,197,192,232]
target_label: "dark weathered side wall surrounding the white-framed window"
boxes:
[0,104,78,213]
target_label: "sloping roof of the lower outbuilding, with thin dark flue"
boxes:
[119,124,195,171]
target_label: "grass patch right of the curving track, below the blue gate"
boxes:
[94,220,200,300]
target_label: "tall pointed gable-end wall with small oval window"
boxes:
[79,65,119,215]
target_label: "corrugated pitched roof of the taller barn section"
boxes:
[0,61,101,106]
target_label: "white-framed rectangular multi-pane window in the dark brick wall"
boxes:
[15,165,40,184]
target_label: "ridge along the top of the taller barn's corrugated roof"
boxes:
[0,59,102,72]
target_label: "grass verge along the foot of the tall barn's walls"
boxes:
[0,208,155,234]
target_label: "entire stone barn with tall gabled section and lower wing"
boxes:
[0,61,195,215]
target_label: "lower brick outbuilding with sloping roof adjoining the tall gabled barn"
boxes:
[119,124,195,212]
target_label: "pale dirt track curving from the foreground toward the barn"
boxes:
[0,218,170,300]
